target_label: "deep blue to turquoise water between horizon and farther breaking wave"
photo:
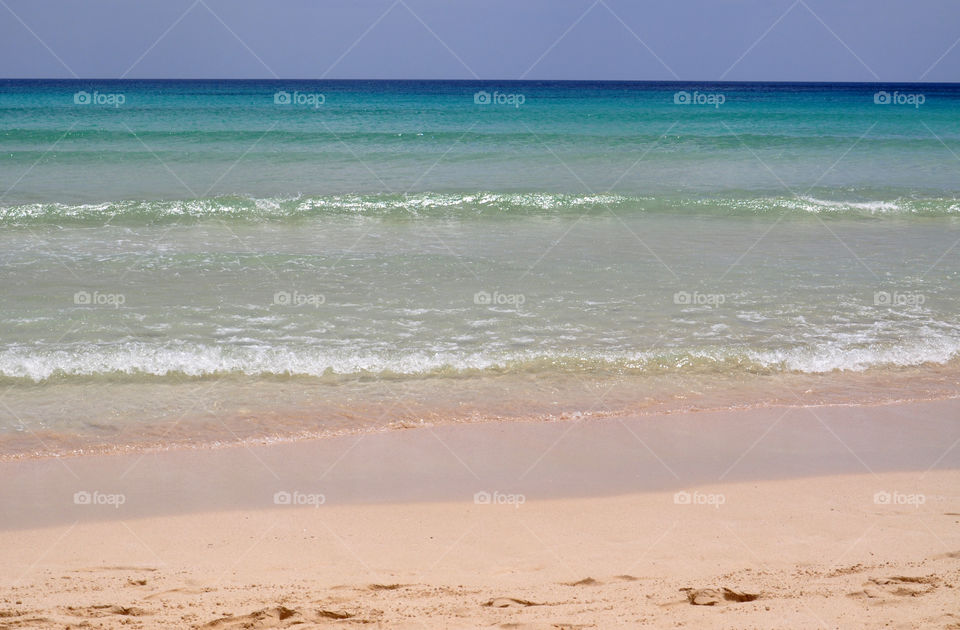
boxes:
[0,81,960,205]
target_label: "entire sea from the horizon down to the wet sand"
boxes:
[0,80,960,457]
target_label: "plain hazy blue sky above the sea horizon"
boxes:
[0,0,960,82]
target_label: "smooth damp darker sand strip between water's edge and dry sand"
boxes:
[0,398,960,529]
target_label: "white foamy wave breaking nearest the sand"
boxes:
[0,337,960,383]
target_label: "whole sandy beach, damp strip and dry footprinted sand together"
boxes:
[0,400,960,628]
